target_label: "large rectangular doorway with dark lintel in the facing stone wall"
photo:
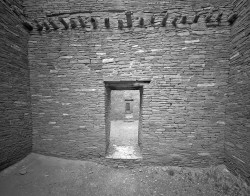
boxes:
[106,83,146,159]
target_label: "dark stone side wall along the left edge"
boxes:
[0,0,32,170]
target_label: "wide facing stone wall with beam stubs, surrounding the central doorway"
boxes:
[25,0,230,166]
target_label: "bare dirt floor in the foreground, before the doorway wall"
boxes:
[0,154,250,196]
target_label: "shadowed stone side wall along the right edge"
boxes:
[225,0,250,183]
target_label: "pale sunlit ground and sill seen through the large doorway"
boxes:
[107,120,141,159]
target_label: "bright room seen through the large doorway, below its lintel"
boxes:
[107,90,141,159]
